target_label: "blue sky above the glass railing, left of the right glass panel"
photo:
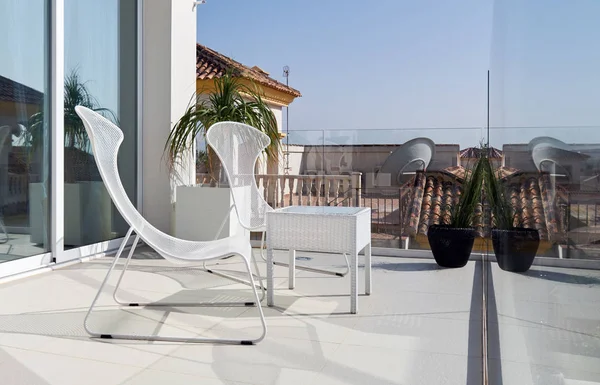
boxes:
[197,0,492,130]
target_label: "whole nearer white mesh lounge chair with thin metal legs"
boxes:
[75,106,267,345]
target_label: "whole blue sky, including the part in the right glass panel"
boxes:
[197,0,600,145]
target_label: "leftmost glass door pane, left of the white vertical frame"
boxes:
[0,0,51,267]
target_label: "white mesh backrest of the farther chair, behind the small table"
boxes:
[206,122,272,230]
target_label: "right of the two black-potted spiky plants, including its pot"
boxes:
[484,154,540,272]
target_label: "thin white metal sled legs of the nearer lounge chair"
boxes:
[84,229,267,345]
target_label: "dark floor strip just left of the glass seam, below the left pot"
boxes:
[467,261,483,385]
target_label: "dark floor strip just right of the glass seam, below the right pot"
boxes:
[486,262,503,385]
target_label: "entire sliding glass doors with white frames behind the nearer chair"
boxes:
[0,0,139,272]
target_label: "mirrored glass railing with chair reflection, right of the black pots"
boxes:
[490,127,600,259]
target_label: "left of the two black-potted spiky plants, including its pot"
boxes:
[427,151,486,268]
